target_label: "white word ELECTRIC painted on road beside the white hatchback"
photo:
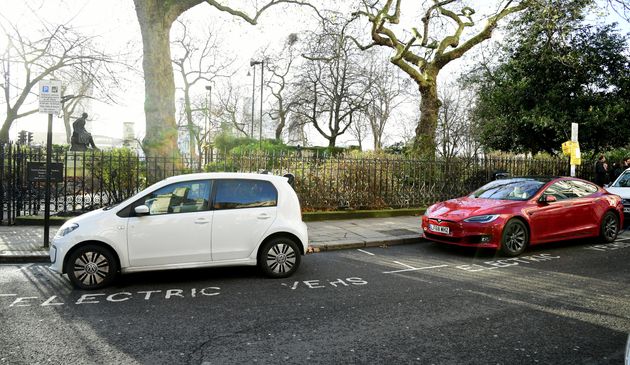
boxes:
[0,286,221,308]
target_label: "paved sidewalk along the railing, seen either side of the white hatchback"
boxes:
[0,216,422,263]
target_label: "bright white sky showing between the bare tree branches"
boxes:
[0,0,630,146]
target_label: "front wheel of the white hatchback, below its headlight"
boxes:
[66,245,118,290]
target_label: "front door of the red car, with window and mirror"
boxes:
[526,181,573,242]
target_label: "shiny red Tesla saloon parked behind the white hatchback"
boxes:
[422,177,623,256]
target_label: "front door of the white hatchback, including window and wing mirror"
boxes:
[127,180,213,267]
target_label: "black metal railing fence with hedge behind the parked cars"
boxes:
[0,144,593,224]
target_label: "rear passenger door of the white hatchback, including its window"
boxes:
[212,179,278,261]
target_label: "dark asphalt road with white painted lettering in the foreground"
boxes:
[0,235,630,364]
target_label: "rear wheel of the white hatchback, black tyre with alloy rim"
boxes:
[258,237,302,278]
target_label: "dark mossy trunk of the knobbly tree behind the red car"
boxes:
[413,82,442,159]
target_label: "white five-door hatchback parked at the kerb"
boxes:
[50,173,308,289]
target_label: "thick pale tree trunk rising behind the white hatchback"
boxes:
[134,0,178,157]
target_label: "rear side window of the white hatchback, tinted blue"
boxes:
[214,179,278,209]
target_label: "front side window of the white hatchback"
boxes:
[144,181,211,215]
